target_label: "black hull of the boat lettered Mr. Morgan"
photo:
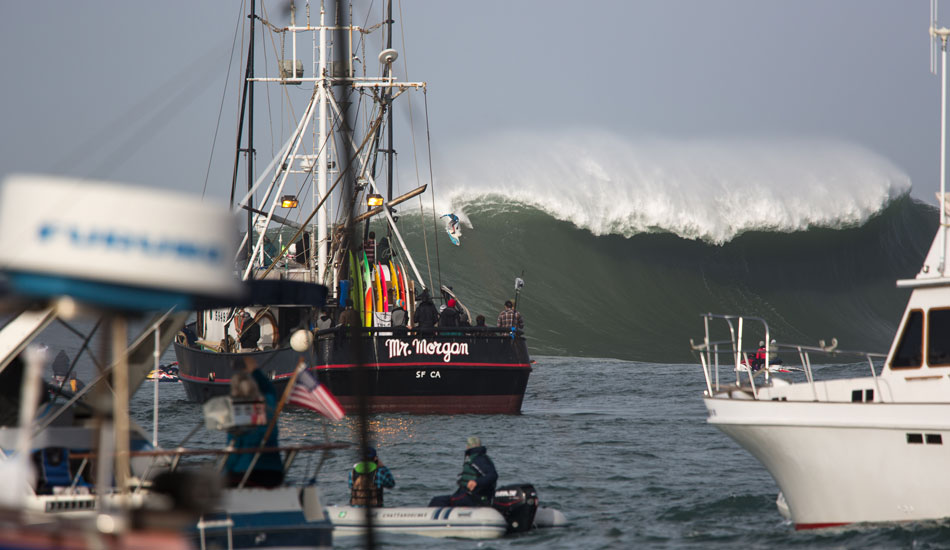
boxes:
[175,331,531,414]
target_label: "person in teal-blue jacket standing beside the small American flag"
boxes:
[224,367,284,487]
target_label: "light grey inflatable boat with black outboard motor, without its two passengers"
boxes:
[326,484,567,539]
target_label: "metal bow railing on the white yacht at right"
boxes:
[690,313,886,401]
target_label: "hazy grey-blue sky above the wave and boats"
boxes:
[0,0,950,202]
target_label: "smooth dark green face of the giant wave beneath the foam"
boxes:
[384,196,937,363]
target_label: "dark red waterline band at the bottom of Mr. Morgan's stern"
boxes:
[337,395,524,415]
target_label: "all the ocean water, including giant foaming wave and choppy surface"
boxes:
[24,136,950,549]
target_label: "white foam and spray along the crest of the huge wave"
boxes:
[422,131,910,244]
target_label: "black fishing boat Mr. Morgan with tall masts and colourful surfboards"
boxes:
[175,2,531,414]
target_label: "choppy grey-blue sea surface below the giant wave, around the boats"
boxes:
[122,353,950,549]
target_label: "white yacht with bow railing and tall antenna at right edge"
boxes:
[693,10,950,529]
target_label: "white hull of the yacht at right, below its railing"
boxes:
[704,397,950,529]
